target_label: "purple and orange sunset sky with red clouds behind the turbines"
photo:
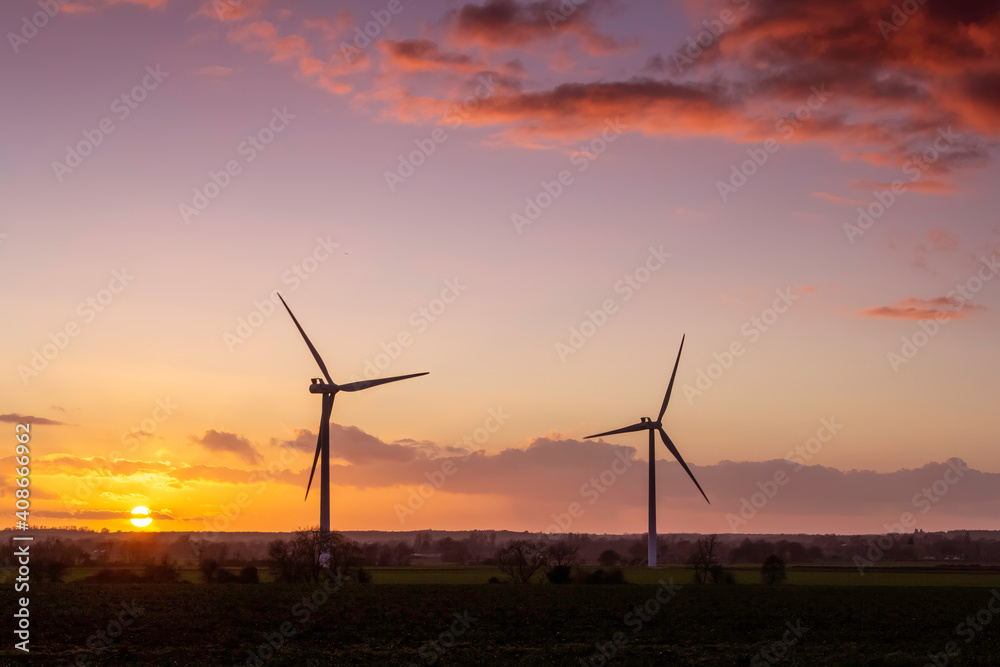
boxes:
[0,0,1000,533]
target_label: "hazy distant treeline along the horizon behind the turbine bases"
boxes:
[0,529,1000,576]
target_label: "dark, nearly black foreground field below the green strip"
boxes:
[0,582,1000,666]
